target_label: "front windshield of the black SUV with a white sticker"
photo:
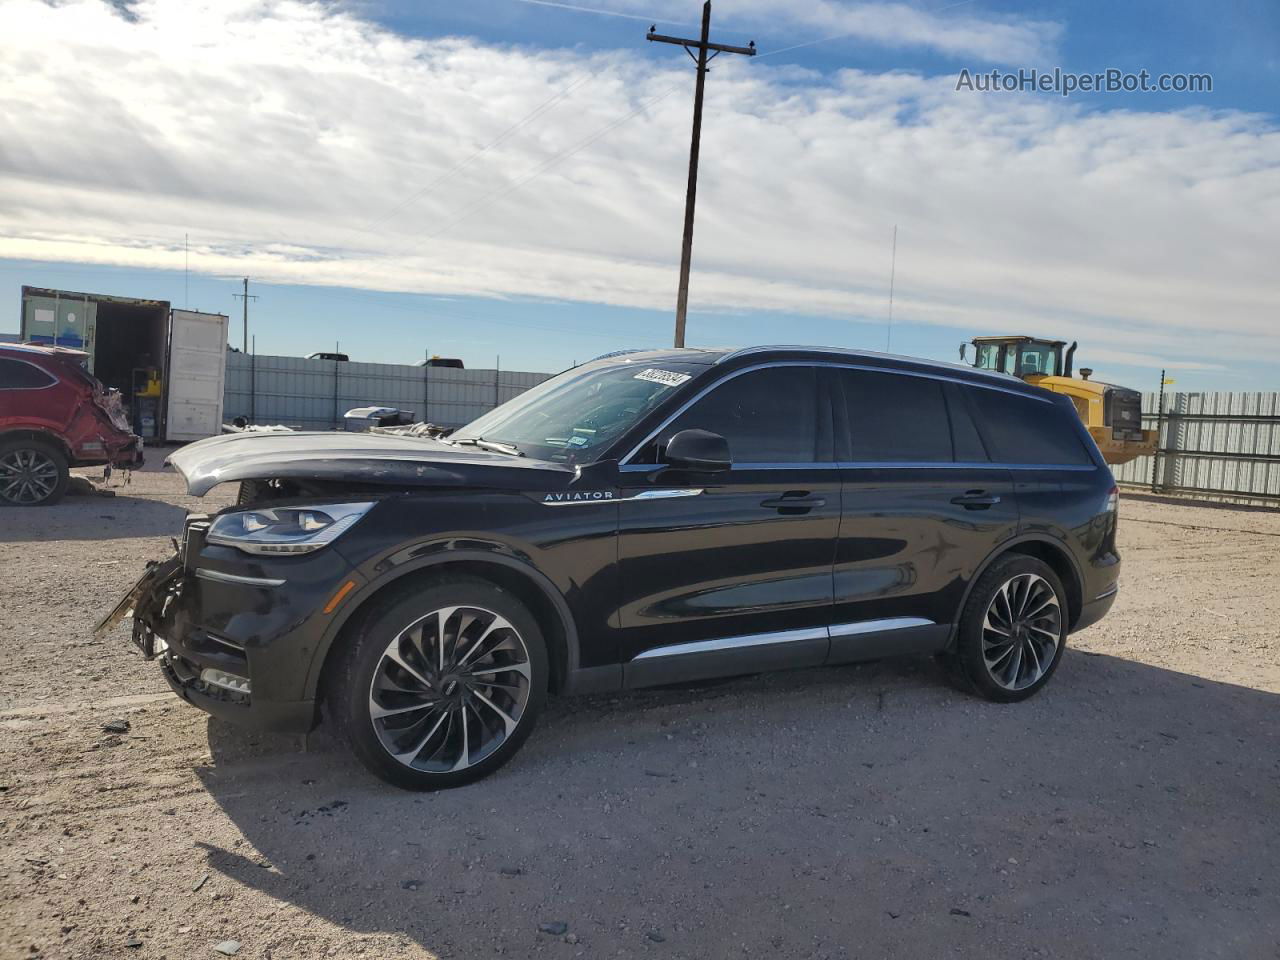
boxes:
[449,360,707,463]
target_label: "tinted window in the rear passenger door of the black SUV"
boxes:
[840,370,955,463]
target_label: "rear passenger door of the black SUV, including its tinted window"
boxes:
[828,367,1018,663]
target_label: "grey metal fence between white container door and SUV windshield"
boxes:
[223,353,550,430]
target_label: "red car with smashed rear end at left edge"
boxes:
[0,344,142,507]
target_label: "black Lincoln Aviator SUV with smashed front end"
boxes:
[101,347,1120,788]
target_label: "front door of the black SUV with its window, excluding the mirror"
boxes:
[618,364,840,686]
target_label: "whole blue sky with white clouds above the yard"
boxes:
[0,0,1280,389]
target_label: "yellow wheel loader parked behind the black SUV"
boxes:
[960,337,1156,465]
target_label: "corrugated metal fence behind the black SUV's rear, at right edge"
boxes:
[1115,393,1280,502]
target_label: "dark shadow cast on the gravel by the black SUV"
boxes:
[201,650,1280,957]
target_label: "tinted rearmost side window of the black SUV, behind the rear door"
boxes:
[965,387,1093,466]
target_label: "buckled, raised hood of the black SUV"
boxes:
[165,433,577,497]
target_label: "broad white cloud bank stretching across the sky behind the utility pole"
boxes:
[0,0,1280,384]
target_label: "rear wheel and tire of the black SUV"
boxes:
[948,554,1070,703]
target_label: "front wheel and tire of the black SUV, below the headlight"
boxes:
[333,577,549,790]
